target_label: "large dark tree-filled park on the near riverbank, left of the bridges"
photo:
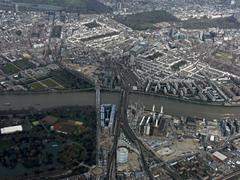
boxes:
[0,106,96,179]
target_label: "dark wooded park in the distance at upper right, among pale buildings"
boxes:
[115,10,240,30]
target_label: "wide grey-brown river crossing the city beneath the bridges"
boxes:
[0,90,240,119]
